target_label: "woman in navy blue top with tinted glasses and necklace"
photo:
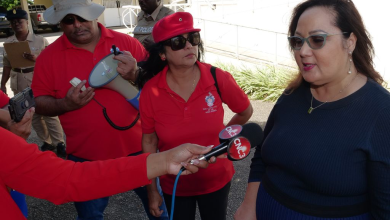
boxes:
[235,0,390,220]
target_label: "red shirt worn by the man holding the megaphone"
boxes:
[31,24,147,160]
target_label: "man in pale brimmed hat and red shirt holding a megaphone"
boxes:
[32,0,164,220]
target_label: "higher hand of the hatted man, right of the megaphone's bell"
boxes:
[114,51,138,82]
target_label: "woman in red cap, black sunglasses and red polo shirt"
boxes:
[137,12,253,220]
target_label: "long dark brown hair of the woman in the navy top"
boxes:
[287,0,383,92]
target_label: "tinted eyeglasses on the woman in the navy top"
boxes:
[288,32,348,50]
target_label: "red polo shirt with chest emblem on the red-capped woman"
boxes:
[140,62,250,196]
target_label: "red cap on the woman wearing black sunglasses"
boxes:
[152,12,200,43]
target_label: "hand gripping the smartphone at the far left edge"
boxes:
[7,107,35,139]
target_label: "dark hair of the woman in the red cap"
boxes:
[136,40,204,89]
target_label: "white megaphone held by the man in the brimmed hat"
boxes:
[88,48,141,110]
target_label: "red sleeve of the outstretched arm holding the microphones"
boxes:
[0,128,150,220]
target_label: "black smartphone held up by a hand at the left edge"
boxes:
[8,87,35,122]
